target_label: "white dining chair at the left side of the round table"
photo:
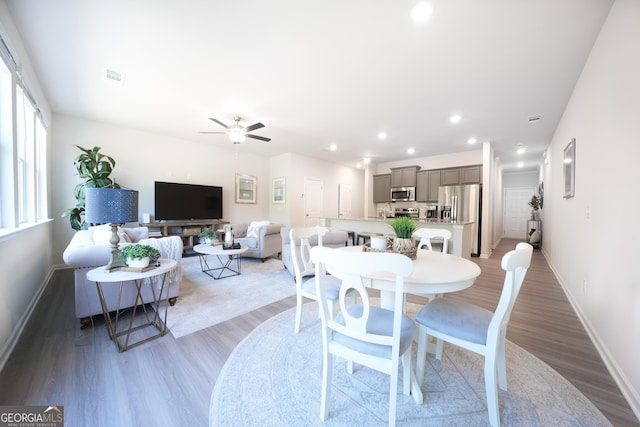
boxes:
[289,226,340,334]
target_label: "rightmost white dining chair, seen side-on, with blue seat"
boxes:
[415,243,533,426]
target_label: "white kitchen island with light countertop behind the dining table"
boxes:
[322,218,475,259]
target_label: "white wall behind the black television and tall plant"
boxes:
[51,114,271,262]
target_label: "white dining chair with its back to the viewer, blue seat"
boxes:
[311,247,416,426]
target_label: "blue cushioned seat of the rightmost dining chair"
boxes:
[415,298,493,344]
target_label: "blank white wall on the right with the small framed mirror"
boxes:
[543,0,640,416]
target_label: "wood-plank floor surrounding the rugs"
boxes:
[0,240,640,427]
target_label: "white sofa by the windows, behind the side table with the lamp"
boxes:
[62,226,183,326]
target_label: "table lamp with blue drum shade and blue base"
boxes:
[84,188,138,271]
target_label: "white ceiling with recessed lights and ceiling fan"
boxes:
[7,0,612,171]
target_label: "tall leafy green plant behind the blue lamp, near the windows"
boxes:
[62,145,120,230]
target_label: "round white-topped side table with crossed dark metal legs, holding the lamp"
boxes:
[87,259,178,352]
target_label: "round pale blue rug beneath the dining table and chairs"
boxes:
[209,303,611,427]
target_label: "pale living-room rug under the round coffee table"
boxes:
[167,255,296,338]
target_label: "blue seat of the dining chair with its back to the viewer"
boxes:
[333,304,416,359]
